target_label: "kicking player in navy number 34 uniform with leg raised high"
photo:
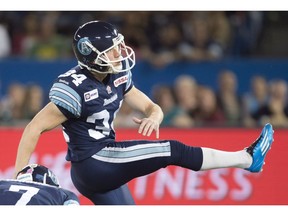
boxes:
[15,21,274,205]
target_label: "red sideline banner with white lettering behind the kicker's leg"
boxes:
[0,128,288,205]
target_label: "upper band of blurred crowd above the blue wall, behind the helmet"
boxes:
[0,11,264,61]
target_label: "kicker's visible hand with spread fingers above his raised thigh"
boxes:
[133,117,159,139]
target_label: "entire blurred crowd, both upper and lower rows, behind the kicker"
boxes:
[0,11,288,127]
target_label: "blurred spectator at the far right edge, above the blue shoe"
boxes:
[253,79,288,127]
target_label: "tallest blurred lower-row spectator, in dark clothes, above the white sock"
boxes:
[216,69,242,126]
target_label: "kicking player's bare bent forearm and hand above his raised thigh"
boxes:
[124,86,163,138]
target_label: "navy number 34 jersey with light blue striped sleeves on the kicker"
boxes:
[49,66,133,161]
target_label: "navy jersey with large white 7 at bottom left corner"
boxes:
[0,179,79,205]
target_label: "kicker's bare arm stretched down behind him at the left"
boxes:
[13,102,67,178]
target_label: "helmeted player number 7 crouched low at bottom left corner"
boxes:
[0,164,79,205]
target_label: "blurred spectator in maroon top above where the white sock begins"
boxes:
[195,86,226,127]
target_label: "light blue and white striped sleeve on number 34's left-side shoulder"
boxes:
[49,83,82,117]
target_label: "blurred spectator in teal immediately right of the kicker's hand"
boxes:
[152,85,194,128]
